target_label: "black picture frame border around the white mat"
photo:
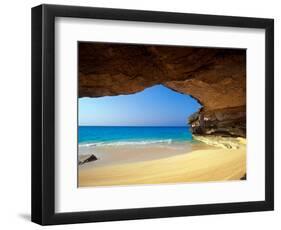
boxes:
[31,5,274,225]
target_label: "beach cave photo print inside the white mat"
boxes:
[78,42,247,187]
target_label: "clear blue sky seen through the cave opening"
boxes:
[79,85,201,126]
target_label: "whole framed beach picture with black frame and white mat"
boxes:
[31,4,274,225]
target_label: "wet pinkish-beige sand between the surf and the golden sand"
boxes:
[78,141,210,167]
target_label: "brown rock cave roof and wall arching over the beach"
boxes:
[78,42,246,137]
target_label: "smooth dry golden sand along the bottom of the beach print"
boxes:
[79,147,246,187]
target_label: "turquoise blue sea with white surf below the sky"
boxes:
[78,126,192,146]
